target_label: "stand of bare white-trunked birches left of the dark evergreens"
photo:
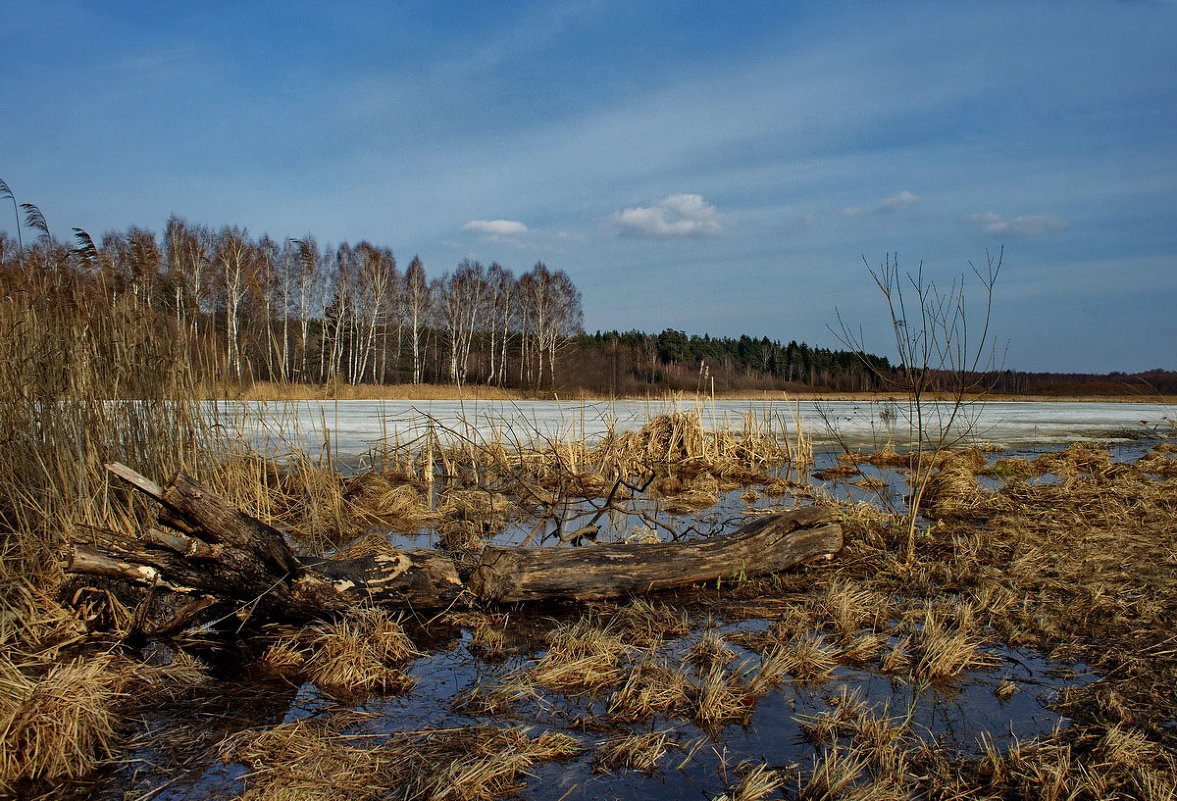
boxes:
[0,181,583,389]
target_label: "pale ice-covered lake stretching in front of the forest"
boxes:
[210,400,1177,465]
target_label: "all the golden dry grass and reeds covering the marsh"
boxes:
[9,286,1177,799]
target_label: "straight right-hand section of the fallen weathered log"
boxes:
[470,508,842,602]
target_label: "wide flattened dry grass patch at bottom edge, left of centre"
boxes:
[222,716,580,801]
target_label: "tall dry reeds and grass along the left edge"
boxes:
[0,274,204,785]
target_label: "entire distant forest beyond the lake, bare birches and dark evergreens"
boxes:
[0,182,1177,395]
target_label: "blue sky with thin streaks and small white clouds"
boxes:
[0,0,1177,372]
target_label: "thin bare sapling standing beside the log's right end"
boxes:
[833,248,1004,563]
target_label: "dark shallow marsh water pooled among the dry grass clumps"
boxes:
[75,442,1152,801]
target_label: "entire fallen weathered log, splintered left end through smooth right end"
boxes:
[67,465,842,626]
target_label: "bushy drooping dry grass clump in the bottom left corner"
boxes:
[0,658,125,788]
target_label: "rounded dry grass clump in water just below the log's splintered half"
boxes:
[306,609,420,697]
